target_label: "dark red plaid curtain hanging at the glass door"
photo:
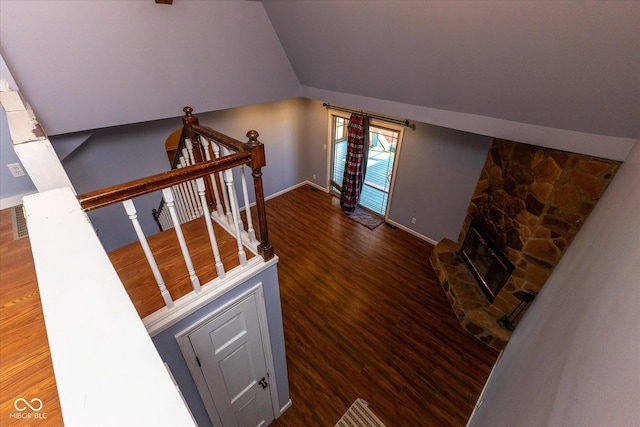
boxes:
[340,114,369,215]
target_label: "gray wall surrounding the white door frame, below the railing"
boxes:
[153,265,289,427]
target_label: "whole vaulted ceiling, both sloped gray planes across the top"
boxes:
[0,0,640,158]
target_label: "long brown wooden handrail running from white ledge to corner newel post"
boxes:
[78,152,251,211]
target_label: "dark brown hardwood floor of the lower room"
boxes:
[267,186,498,427]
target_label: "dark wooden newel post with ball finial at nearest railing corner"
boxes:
[247,130,274,261]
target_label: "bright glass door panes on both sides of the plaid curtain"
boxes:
[330,114,402,216]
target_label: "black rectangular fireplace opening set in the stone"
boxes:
[457,221,514,303]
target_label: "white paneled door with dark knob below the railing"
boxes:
[188,293,274,427]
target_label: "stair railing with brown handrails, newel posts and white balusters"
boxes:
[78,108,274,308]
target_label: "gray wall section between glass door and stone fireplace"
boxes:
[389,123,492,242]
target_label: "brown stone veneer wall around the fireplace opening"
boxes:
[430,139,620,350]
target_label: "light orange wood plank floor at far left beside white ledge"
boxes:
[0,209,62,427]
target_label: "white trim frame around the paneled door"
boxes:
[175,282,280,426]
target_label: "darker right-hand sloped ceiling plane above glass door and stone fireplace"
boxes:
[263,0,640,138]
